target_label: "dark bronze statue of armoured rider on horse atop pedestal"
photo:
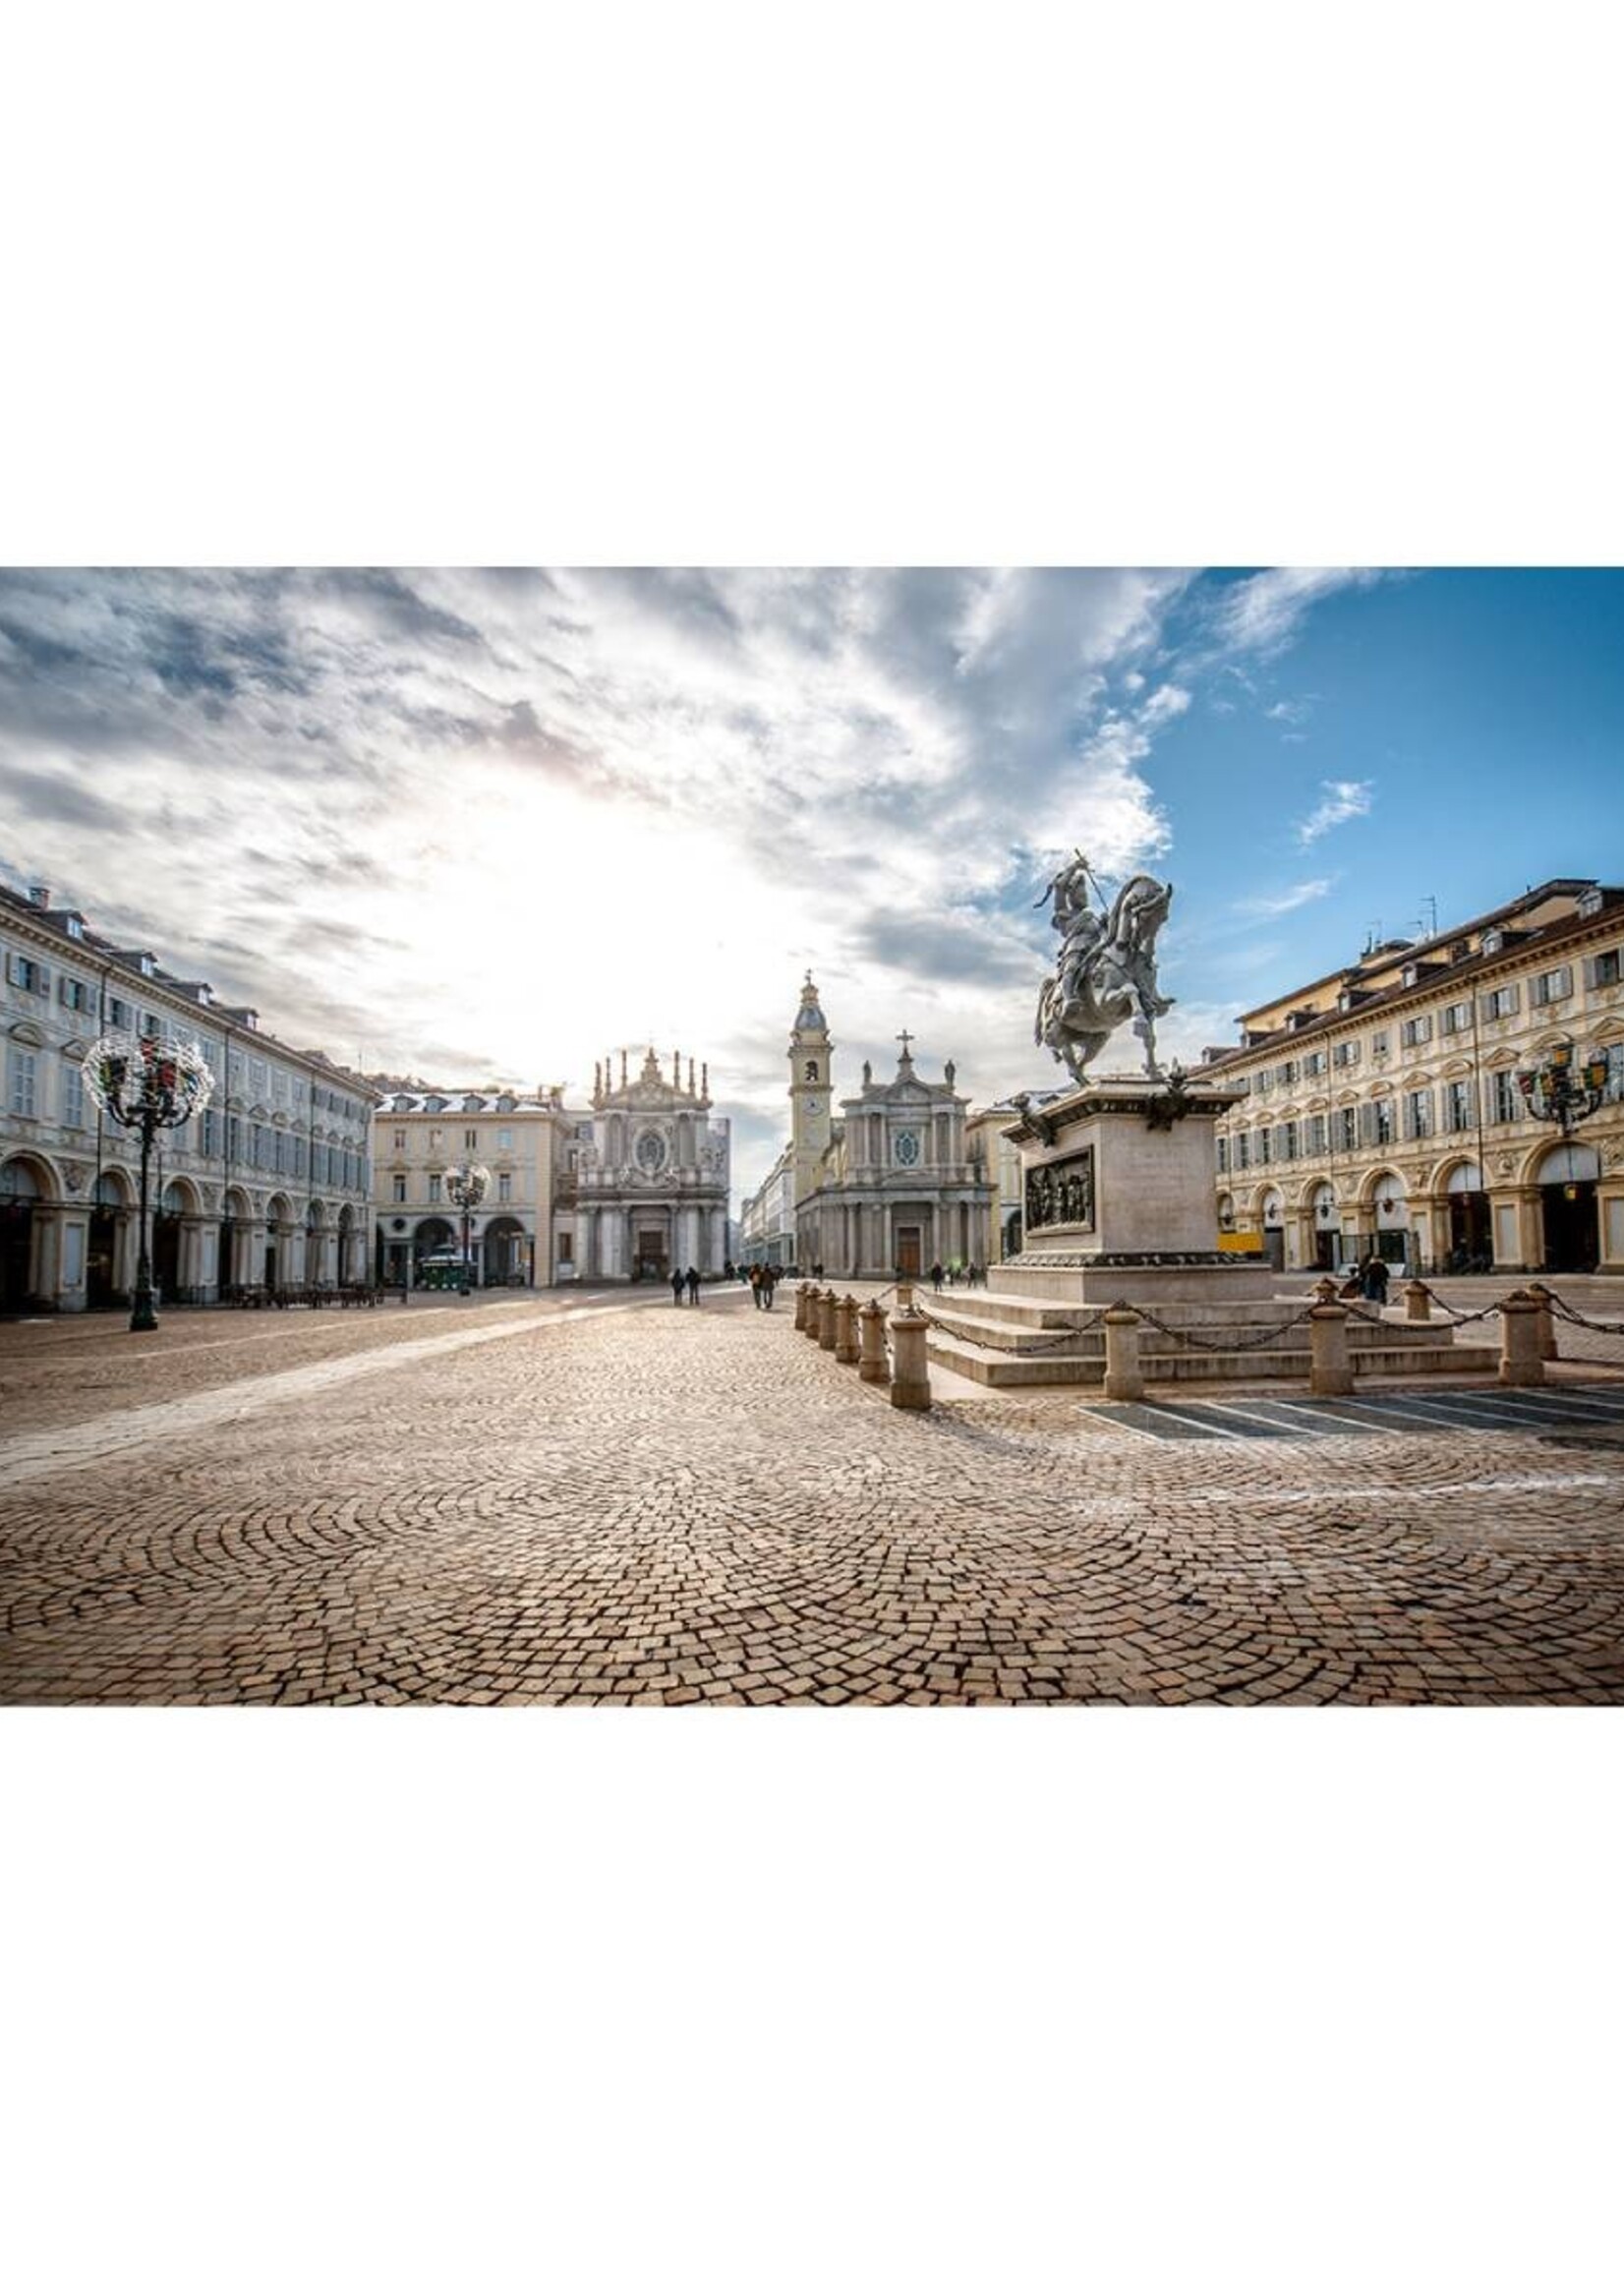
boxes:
[1037,852,1174,1087]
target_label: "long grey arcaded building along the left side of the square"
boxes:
[0,885,376,1312]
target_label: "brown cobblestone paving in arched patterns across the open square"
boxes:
[0,1292,1624,1706]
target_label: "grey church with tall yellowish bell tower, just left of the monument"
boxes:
[744,971,992,1280]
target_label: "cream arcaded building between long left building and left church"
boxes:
[373,1087,556,1287]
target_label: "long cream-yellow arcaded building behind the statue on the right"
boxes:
[1198,878,1624,1273]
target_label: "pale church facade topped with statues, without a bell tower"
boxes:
[552,1048,730,1280]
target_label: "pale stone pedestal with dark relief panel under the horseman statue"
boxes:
[987,1080,1271,1303]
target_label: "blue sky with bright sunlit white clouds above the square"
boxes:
[0,568,1624,1194]
